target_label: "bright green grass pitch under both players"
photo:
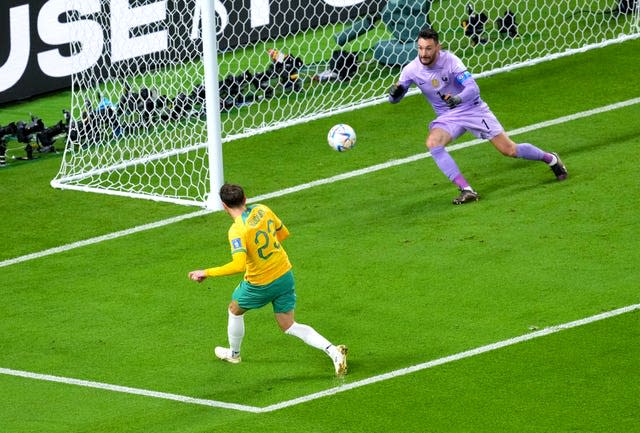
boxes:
[0,40,640,433]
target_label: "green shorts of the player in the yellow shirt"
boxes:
[231,271,296,313]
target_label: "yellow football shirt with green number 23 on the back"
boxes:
[229,204,291,285]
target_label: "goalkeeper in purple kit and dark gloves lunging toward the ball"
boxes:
[389,29,567,204]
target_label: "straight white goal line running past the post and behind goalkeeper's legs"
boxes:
[0,98,640,268]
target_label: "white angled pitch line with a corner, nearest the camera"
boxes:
[0,304,640,413]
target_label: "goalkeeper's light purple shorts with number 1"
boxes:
[429,103,504,140]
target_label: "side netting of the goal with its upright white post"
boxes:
[51,0,223,209]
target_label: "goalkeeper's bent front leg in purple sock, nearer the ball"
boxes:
[426,121,479,204]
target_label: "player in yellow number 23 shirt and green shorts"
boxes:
[189,184,347,376]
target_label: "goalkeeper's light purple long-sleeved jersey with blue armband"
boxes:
[398,50,488,116]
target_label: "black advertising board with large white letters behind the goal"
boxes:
[0,0,386,104]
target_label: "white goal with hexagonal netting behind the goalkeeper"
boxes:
[49,0,640,206]
